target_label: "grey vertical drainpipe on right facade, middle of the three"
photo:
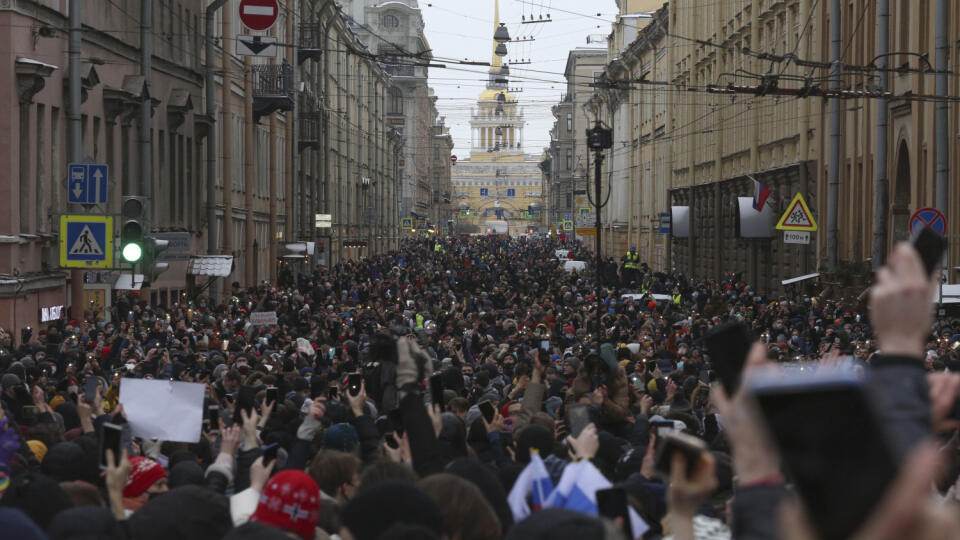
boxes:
[873,0,890,271]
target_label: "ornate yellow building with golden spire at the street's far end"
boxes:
[451,1,543,234]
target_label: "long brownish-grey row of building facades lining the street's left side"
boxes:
[0,0,402,328]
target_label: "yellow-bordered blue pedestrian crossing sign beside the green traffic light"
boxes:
[60,215,113,268]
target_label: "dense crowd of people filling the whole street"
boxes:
[0,236,960,540]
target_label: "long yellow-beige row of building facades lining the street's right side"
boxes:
[580,0,960,291]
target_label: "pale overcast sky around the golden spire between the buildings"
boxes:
[419,0,617,159]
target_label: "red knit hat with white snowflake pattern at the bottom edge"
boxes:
[250,469,320,540]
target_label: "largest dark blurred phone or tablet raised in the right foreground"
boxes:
[750,370,897,539]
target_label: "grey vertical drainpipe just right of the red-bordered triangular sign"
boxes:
[827,0,843,272]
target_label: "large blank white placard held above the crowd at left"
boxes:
[120,379,206,443]
